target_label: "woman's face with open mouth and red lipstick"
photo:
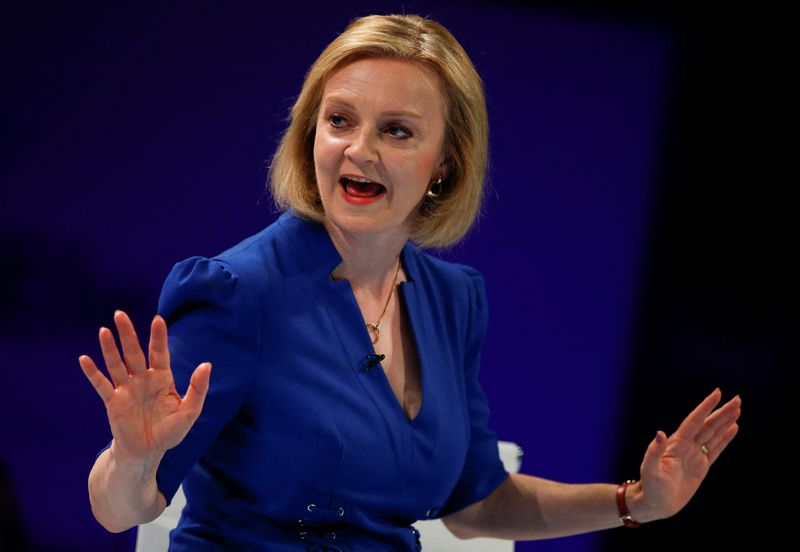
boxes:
[314,59,446,243]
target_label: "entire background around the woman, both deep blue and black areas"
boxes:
[0,0,798,551]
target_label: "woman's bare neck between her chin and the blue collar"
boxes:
[324,220,408,296]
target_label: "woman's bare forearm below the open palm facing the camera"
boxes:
[89,444,166,533]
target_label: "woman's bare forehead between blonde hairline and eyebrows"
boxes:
[322,58,445,117]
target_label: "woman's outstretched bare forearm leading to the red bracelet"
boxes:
[445,474,649,540]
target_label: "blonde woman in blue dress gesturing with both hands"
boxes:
[80,16,741,551]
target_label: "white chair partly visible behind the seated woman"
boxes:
[136,441,522,552]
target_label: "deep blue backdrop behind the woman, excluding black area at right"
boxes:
[0,0,780,551]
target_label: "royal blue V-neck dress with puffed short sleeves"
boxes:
[150,212,508,552]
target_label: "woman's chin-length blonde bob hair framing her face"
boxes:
[269,15,489,248]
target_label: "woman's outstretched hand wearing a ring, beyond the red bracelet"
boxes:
[631,389,742,521]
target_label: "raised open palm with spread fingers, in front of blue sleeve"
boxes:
[78,311,211,462]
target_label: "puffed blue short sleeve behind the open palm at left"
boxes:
[156,257,261,503]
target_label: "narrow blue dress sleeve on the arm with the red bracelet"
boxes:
[439,267,508,517]
